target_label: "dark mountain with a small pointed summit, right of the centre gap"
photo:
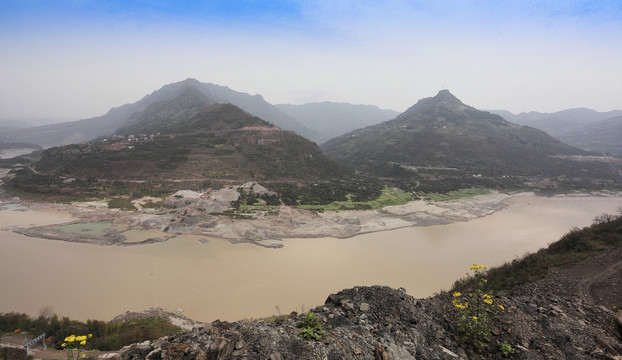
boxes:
[322,90,619,190]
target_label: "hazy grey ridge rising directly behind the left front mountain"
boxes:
[0,78,317,147]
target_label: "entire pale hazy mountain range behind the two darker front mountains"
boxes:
[0,78,622,154]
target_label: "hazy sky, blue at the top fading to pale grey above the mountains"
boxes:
[0,0,622,118]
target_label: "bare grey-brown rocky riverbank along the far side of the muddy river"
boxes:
[0,183,511,247]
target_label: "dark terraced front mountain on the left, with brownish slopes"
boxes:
[30,88,351,184]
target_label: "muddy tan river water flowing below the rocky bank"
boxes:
[0,195,622,321]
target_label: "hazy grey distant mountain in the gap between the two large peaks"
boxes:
[275,101,399,144]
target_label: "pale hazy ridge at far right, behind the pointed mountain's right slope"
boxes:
[490,108,622,155]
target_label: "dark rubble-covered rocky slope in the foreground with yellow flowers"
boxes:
[121,249,622,360]
